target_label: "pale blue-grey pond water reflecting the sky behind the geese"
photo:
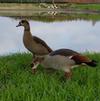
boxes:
[0,16,100,55]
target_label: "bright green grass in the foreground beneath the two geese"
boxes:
[0,53,100,101]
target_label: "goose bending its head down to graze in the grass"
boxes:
[32,49,97,78]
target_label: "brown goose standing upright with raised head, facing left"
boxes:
[16,20,52,56]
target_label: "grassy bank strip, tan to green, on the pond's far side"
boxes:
[0,3,100,11]
